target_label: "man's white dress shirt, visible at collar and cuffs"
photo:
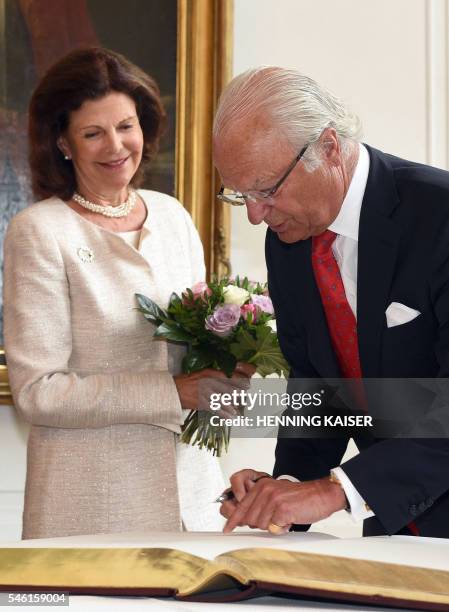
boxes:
[279,144,374,521]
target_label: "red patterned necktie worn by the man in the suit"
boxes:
[312,230,419,536]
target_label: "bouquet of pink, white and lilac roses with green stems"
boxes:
[136,277,288,456]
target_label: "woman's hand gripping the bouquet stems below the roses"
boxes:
[174,363,256,417]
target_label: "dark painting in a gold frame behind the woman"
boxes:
[0,0,233,404]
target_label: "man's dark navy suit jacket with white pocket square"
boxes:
[266,147,449,537]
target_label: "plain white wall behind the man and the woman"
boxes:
[0,0,448,540]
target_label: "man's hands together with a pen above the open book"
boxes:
[220,470,346,533]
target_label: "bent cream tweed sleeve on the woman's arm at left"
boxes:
[4,214,182,432]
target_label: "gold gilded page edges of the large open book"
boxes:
[0,548,449,610]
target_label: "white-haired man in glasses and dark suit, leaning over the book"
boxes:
[214,67,449,537]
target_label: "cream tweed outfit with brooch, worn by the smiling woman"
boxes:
[4,190,223,538]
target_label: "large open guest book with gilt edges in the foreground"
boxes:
[0,532,449,611]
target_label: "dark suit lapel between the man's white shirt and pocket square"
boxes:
[357,147,400,378]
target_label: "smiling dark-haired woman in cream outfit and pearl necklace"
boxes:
[4,48,244,538]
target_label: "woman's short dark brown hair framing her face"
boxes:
[28,47,166,200]
